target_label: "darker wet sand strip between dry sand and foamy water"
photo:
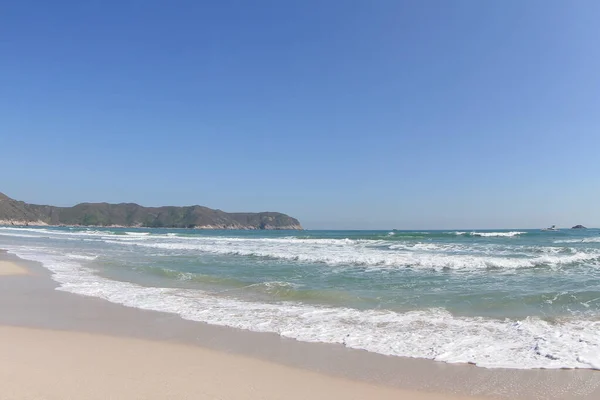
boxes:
[0,253,600,399]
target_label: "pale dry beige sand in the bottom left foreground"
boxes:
[0,326,480,400]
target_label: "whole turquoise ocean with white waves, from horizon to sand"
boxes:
[0,227,600,369]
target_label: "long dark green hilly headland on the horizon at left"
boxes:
[0,193,302,229]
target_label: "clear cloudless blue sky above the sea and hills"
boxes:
[0,0,600,229]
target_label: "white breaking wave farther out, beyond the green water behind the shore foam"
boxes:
[102,237,600,270]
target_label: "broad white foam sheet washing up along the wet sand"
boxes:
[5,247,600,369]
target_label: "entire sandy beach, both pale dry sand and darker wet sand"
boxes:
[0,253,600,399]
